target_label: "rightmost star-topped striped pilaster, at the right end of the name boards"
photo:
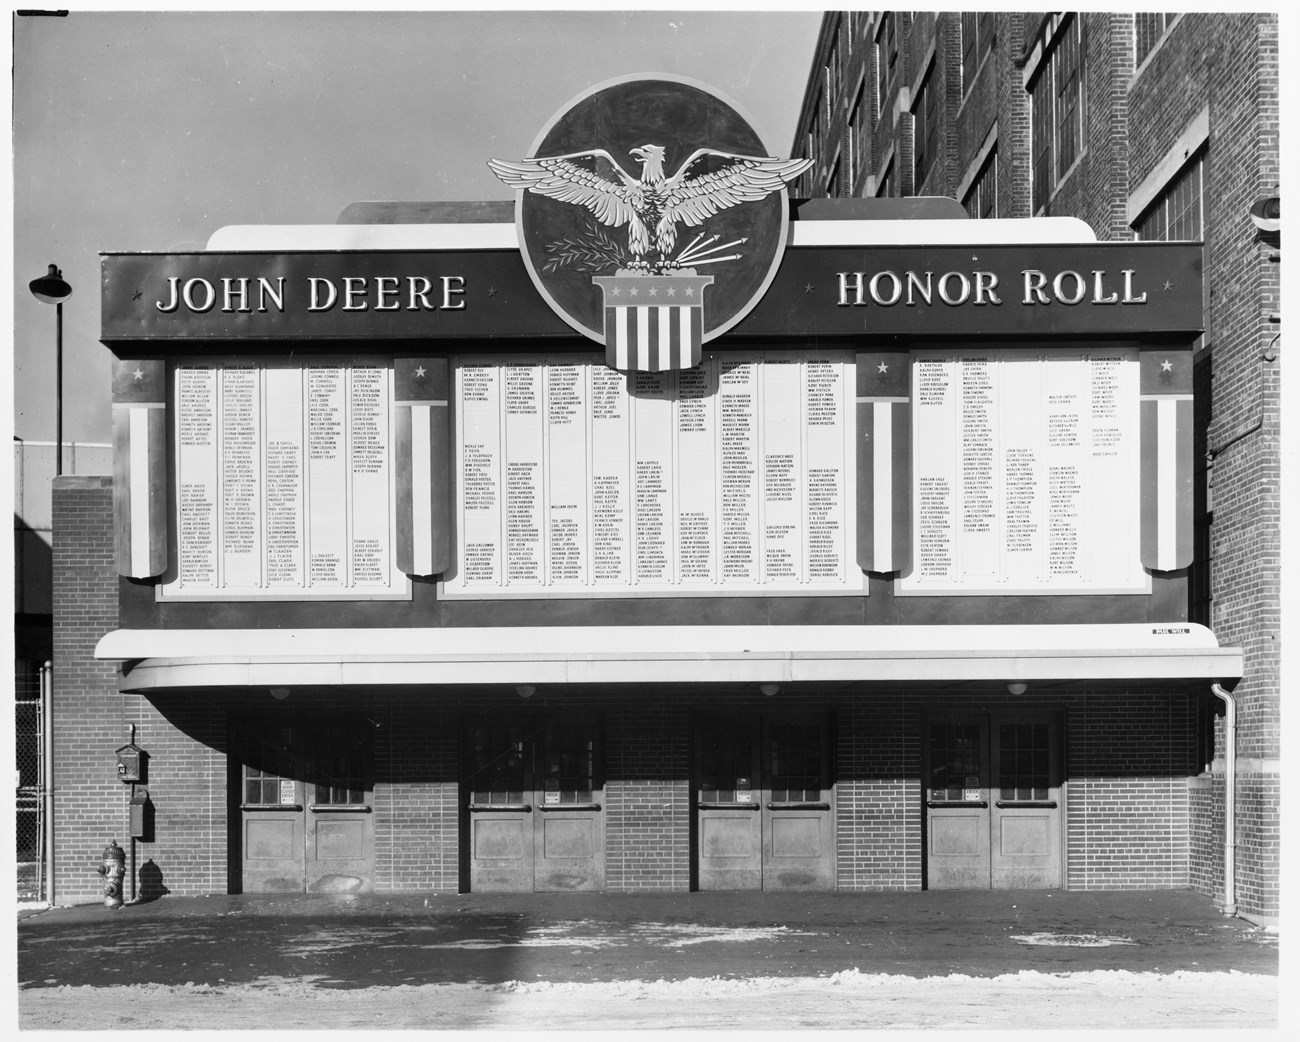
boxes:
[1140,351,1192,572]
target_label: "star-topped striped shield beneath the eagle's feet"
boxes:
[592,275,714,373]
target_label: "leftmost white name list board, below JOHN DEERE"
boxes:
[160,362,408,600]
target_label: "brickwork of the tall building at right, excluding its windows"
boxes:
[790,4,1282,916]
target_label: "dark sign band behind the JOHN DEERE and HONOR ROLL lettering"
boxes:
[103,243,1203,340]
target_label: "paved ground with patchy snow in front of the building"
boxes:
[18,891,1278,1026]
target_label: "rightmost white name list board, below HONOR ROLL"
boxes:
[900,348,1148,594]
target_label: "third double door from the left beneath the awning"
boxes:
[693,715,835,890]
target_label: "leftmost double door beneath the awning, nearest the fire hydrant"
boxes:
[238,721,374,894]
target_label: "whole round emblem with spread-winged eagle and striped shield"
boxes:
[488,75,811,373]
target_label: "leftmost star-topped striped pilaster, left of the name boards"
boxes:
[113,359,168,579]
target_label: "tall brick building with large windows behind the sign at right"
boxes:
[792,12,1281,917]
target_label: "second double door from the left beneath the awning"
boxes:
[462,715,605,893]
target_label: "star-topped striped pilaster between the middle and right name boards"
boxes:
[857,351,911,573]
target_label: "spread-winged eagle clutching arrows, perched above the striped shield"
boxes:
[488,144,813,275]
